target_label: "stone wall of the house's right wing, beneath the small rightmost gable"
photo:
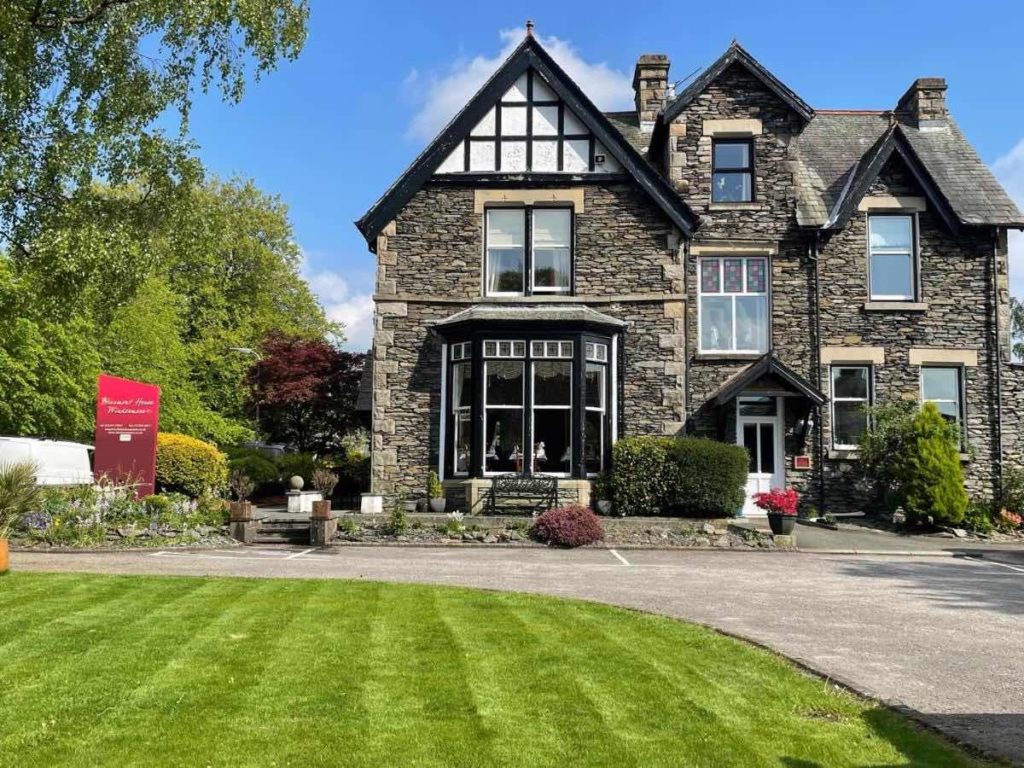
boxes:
[820,159,996,507]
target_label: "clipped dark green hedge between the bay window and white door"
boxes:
[611,436,748,517]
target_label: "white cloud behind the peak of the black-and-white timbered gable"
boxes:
[402,29,633,140]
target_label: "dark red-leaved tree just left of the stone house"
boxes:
[248,334,367,454]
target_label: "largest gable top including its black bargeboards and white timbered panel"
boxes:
[355,35,699,250]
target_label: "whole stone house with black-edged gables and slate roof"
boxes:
[357,31,1024,512]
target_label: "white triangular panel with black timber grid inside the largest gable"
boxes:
[435,68,622,174]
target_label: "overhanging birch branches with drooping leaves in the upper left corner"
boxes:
[0,0,308,250]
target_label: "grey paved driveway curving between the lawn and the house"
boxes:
[12,547,1024,763]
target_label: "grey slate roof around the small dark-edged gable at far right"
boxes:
[792,111,1024,226]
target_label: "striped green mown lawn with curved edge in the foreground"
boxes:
[0,573,987,768]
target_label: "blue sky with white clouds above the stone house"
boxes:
[180,0,1024,348]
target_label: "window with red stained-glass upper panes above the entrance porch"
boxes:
[697,256,769,353]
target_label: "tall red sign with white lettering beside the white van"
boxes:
[93,374,160,497]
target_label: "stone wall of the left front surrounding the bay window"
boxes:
[372,183,685,495]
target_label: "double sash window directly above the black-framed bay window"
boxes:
[484,207,572,296]
